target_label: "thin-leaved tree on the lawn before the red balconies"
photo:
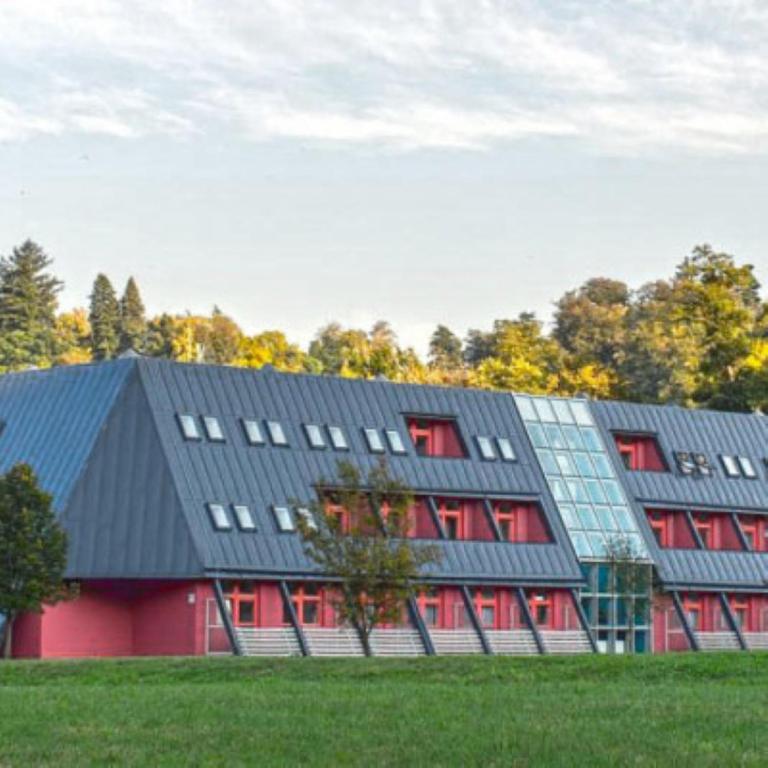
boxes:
[299,462,440,656]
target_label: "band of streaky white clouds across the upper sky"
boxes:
[0,0,768,154]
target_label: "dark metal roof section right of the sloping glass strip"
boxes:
[591,402,768,589]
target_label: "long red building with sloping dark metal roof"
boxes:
[0,357,768,657]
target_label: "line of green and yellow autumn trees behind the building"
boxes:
[0,240,768,411]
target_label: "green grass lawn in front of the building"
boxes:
[0,653,768,768]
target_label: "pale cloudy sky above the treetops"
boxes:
[0,0,768,351]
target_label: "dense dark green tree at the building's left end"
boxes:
[0,464,73,656]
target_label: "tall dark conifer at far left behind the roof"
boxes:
[0,240,63,371]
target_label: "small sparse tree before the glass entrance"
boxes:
[606,535,653,653]
